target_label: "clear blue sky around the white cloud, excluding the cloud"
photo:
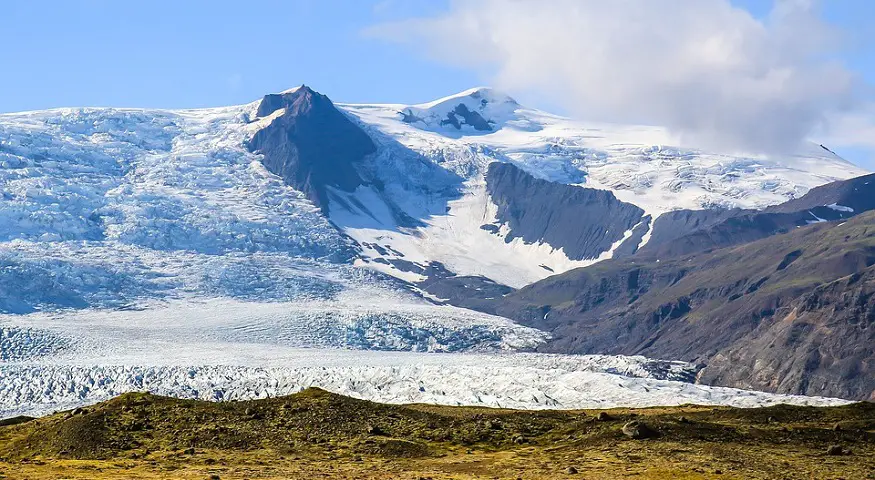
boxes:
[0,0,875,168]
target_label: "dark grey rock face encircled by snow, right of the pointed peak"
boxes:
[486,163,644,260]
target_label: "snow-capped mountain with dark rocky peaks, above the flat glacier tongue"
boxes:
[0,87,863,306]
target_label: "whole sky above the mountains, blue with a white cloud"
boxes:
[0,0,875,170]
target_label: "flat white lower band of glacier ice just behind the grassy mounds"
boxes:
[0,320,847,416]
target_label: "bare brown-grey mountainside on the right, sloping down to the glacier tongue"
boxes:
[485,208,875,399]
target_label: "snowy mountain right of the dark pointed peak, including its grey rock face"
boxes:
[331,88,864,287]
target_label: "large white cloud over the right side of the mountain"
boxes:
[370,0,860,151]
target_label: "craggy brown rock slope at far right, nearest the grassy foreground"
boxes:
[701,267,875,400]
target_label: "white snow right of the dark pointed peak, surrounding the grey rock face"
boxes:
[331,88,867,287]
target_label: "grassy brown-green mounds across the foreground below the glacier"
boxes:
[0,389,875,480]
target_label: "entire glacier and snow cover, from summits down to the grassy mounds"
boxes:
[0,88,864,415]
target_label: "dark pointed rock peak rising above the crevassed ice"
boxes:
[249,86,376,211]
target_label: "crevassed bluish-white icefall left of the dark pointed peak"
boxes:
[0,104,370,313]
